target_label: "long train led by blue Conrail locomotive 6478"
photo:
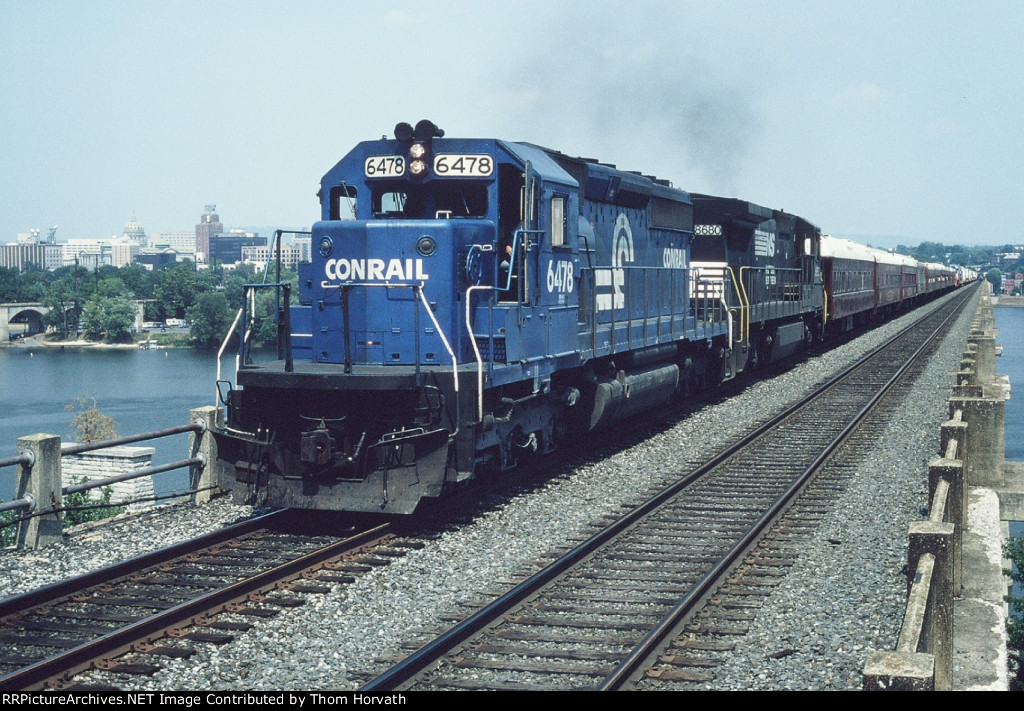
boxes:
[214,121,972,513]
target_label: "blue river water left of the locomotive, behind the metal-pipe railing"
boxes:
[0,347,233,500]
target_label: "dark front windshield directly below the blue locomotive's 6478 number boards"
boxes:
[373,180,487,219]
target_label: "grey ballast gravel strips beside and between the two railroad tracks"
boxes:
[0,288,973,691]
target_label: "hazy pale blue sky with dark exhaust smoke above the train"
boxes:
[0,0,1024,251]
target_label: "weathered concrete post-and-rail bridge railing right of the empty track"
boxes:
[862,285,1009,691]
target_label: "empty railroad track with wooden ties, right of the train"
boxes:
[362,292,973,692]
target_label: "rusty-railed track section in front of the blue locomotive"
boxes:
[0,511,422,691]
